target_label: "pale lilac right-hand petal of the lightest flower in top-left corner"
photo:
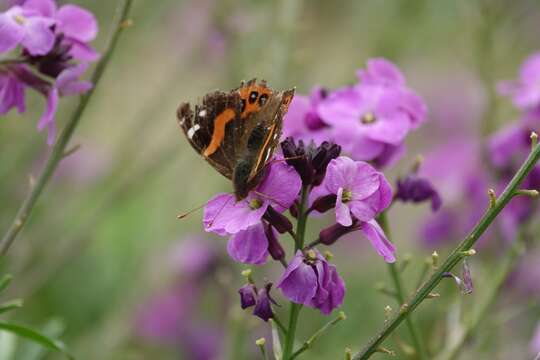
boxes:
[21,17,54,55]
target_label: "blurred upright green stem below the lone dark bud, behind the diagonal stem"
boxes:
[378,211,429,360]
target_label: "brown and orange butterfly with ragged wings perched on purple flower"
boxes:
[177,79,294,200]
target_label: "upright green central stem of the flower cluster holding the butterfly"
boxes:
[283,186,309,360]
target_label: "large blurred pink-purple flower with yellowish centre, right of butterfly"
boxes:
[318,59,426,163]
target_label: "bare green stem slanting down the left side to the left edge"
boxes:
[0,0,133,257]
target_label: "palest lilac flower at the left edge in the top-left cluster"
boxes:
[0,4,55,55]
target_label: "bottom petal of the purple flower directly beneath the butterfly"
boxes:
[227,224,268,265]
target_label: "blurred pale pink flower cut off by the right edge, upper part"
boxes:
[498,53,540,110]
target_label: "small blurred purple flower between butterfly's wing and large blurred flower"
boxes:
[283,87,332,143]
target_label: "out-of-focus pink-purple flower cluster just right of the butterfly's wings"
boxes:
[284,59,426,166]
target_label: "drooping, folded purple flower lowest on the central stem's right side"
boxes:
[277,250,345,315]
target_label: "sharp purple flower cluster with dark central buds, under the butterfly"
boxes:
[203,138,395,320]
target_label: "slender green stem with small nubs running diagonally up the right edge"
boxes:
[354,145,540,360]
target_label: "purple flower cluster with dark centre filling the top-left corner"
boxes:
[0,0,99,145]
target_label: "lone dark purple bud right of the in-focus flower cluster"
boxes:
[396,175,442,211]
